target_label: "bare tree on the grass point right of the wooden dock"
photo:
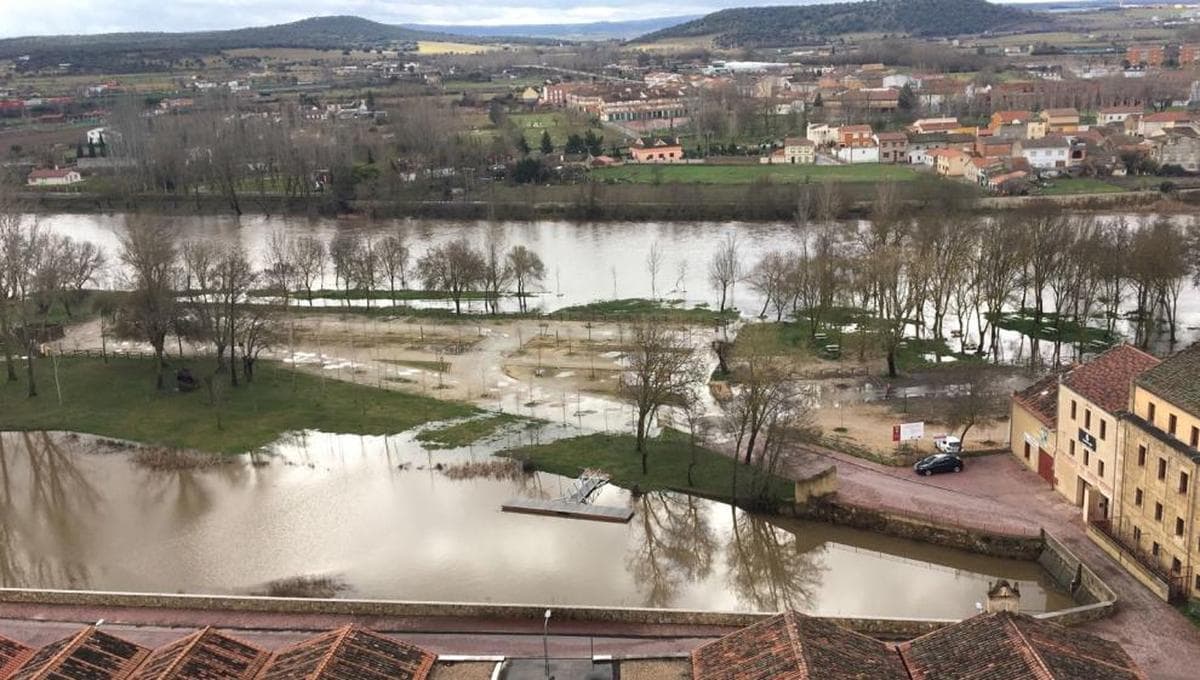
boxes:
[620,323,703,474]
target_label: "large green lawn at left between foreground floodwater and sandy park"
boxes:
[0,359,478,453]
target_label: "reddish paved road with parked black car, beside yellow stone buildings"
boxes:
[797,449,1200,680]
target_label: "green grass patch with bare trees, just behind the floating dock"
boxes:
[502,432,796,501]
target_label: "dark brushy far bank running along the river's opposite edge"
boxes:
[19,180,1200,222]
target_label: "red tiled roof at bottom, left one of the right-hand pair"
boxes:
[691,612,908,680]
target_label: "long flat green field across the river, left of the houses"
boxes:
[592,163,922,185]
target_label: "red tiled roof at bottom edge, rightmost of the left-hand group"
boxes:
[258,626,437,680]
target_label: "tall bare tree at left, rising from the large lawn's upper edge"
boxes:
[119,216,179,390]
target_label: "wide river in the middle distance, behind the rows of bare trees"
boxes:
[37,213,1200,361]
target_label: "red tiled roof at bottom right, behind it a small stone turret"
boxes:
[899,613,1147,680]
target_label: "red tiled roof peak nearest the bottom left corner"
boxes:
[8,626,150,680]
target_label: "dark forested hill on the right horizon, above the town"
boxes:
[636,0,1051,47]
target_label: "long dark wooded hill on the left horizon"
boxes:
[0,17,530,73]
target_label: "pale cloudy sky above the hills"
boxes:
[0,0,1065,37]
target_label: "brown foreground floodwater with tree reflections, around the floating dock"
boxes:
[0,432,1072,618]
